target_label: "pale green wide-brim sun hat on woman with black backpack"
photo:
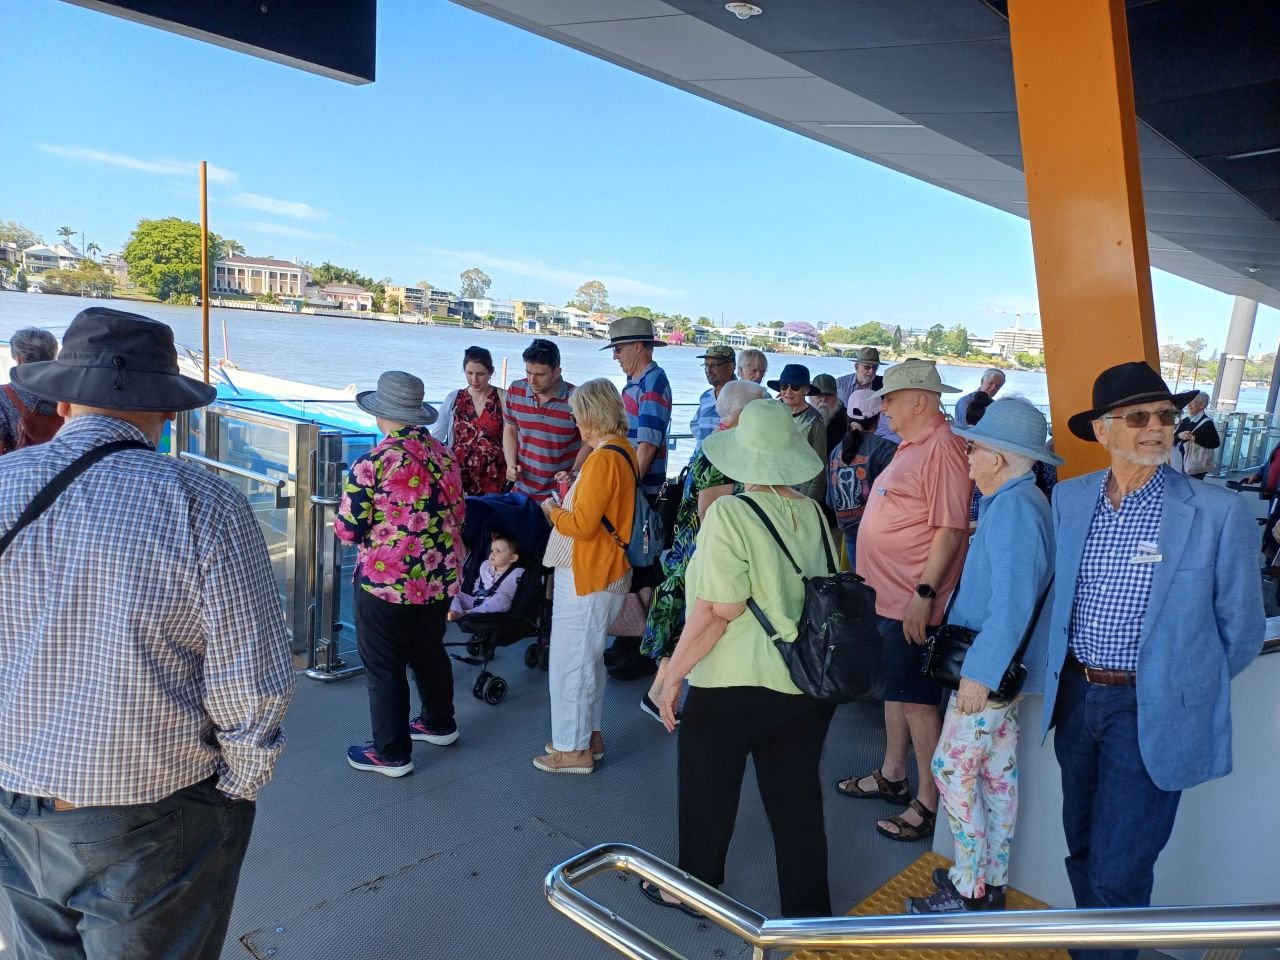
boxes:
[703,399,823,486]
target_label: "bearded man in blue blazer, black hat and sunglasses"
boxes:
[1042,362,1265,960]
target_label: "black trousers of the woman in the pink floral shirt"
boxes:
[355,585,453,762]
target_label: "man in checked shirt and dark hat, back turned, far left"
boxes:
[0,307,293,960]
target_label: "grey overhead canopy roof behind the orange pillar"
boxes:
[454,0,1280,308]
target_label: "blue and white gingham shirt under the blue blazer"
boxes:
[1070,467,1171,671]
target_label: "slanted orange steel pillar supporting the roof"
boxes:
[1009,0,1160,475]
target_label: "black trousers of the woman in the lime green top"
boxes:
[678,686,833,916]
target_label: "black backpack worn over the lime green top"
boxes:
[739,494,884,704]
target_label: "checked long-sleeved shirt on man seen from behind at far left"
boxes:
[0,416,293,806]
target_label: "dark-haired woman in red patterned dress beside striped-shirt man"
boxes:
[431,347,507,497]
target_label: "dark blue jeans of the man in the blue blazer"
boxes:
[1053,671,1181,960]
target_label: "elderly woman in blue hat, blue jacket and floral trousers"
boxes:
[906,398,1062,913]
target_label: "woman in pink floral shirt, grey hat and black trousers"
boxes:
[333,370,465,777]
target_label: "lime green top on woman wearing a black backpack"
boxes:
[685,493,831,695]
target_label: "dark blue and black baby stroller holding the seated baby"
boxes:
[445,493,550,705]
